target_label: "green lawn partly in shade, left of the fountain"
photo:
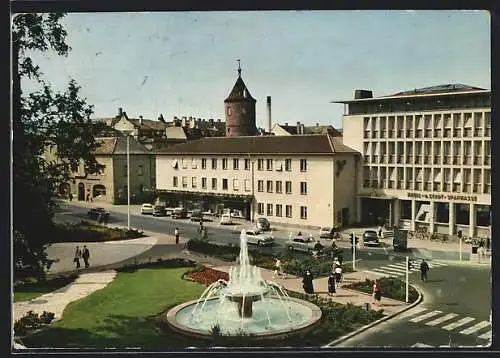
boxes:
[24,268,204,349]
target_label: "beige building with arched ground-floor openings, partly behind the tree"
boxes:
[70,136,156,204]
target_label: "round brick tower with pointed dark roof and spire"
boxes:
[224,60,257,137]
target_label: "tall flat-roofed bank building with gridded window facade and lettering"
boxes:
[333,84,491,237]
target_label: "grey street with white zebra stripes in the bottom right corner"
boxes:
[336,264,492,347]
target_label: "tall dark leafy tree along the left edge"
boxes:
[12,14,102,279]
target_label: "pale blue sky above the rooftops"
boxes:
[21,10,491,128]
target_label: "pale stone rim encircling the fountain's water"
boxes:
[166,295,322,339]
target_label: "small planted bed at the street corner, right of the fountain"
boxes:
[345,277,418,303]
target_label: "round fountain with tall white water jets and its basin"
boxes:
[167,230,321,339]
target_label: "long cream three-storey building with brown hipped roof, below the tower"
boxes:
[156,134,359,227]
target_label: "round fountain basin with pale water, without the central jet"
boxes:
[166,295,321,340]
